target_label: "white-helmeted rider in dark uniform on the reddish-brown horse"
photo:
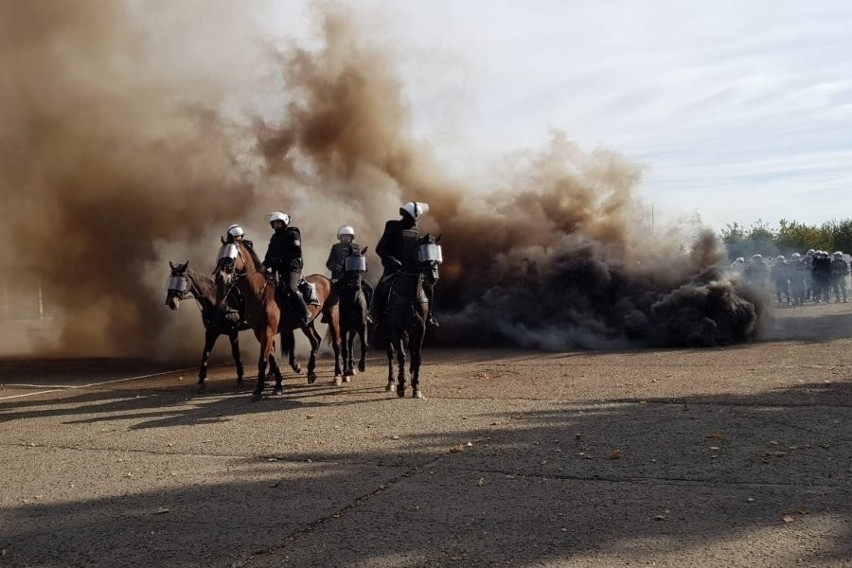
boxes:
[263,211,311,325]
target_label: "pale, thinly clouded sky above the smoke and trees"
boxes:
[266,0,852,228]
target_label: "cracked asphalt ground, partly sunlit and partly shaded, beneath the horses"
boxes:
[0,304,852,568]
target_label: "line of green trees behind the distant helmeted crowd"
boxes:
[719,219,852,259]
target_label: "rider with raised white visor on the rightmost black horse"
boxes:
[370,201,438,327]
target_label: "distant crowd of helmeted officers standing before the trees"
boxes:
[731,249,849,306]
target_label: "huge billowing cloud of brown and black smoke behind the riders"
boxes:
[0,0,764,358]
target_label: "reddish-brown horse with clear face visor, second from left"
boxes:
[215,242,340,400]
